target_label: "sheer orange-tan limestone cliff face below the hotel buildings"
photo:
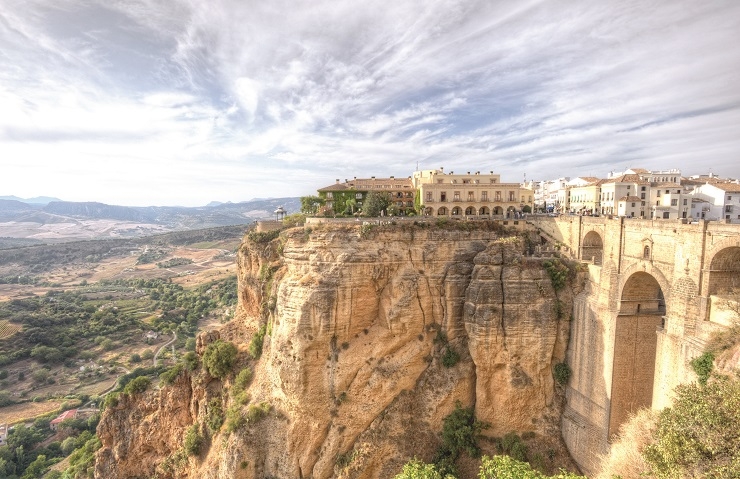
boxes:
[96,226,570,478]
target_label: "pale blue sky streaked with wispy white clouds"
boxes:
[0,0,740,206]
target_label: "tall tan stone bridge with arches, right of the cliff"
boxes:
[528,216,740,475]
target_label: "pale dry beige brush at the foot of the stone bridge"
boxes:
[595,409,658,479]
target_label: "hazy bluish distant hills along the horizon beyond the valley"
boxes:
[0,198,300,242]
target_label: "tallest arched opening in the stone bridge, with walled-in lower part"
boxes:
[609,271,666,436]
